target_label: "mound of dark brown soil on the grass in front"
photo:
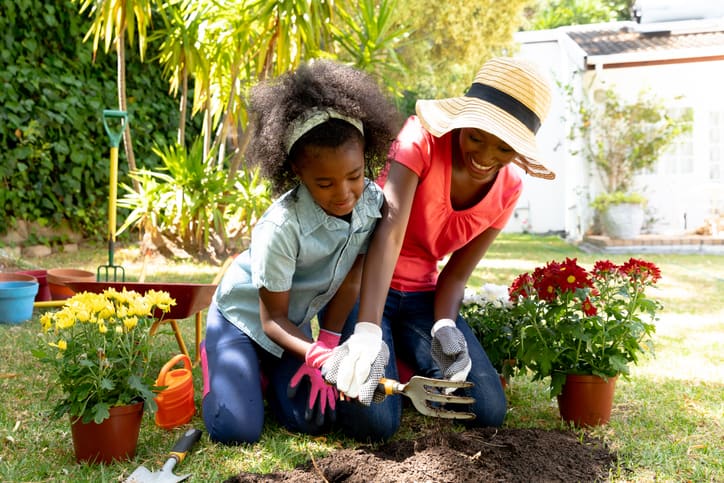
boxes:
[226,428,616,483]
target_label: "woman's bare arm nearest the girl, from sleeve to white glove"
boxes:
[359,161,419,325]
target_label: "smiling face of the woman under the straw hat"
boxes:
[459,128,518,184]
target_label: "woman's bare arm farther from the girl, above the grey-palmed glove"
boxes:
[435,228,500,326]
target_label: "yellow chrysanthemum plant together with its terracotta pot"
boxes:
[33,288,176,462]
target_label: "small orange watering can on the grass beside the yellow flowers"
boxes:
[155,354,196,429]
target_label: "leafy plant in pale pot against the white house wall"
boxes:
[568,87,692,239]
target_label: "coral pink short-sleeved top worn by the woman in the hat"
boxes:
[377,115,523,292]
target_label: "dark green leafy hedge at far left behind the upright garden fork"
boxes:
[0,0,198,238]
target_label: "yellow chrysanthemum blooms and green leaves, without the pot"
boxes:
[33,288,176,423]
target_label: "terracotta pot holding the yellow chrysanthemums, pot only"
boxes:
[70,401,143,463]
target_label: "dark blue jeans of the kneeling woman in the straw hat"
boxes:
[382,289,506,426]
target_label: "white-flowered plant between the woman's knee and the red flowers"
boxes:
[460,283,519,387]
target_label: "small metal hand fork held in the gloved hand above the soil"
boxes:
[377,376,475,419]
